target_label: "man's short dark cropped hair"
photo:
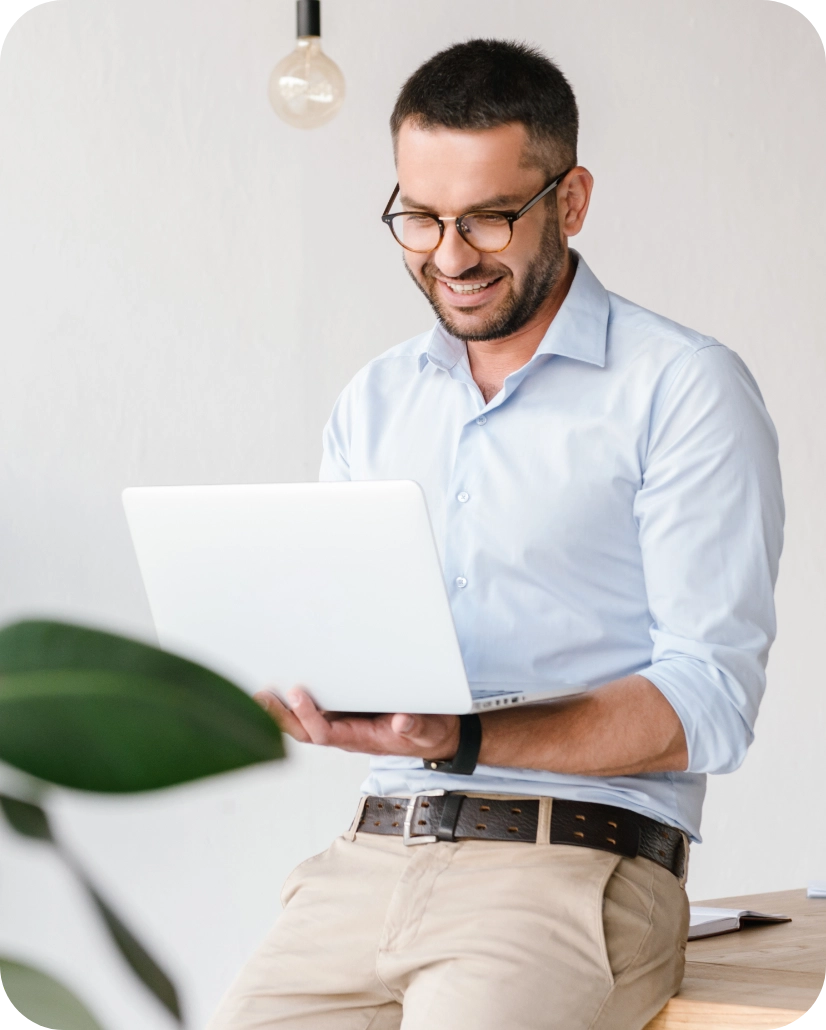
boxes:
[390,39,579,174]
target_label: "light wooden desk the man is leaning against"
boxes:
[646,890,826,1030]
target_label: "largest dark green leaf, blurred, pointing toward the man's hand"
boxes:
[0,621,284,793]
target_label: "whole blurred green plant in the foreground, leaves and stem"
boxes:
[0,621,284,1030]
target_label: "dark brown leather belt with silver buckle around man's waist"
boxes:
[357,791,687,878]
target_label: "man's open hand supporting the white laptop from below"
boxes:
[253,688,459,760]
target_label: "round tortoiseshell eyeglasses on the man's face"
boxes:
[381,168,572,254]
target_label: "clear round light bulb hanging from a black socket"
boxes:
[269,0,344,129]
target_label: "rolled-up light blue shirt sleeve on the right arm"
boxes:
[634,344,784,773]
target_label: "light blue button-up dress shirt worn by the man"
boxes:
[320,255,784,839]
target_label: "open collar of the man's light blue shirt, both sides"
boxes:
[418,250,610,372]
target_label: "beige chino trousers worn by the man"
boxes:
[207,807,688,1030]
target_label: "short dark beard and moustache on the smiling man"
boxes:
[405,211,565,343]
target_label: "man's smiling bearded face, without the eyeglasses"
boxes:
[397,122,566,340]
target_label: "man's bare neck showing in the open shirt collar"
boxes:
[467,251,576,402]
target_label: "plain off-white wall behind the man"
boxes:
[0,0,826,1030]
